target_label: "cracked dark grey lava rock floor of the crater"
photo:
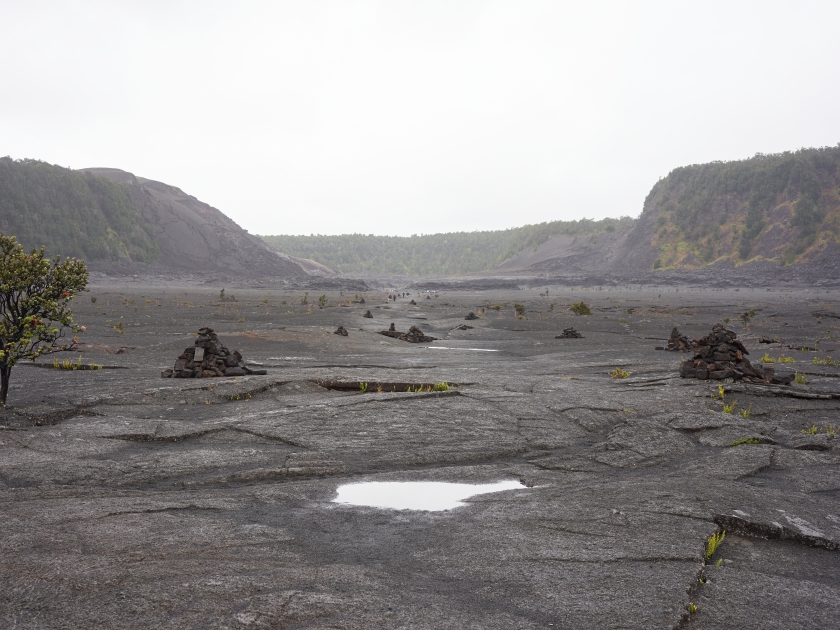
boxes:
[0,286,840,630]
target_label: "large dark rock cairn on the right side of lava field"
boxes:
[680,324,793,385]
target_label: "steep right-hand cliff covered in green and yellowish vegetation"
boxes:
[642,145,840,269]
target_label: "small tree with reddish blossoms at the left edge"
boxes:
[0,234,88,407]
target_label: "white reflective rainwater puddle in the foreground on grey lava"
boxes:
[333,480,527,512]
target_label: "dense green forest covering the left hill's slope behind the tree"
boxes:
[0,157,159,263]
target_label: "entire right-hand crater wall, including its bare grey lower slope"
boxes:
[497,146,840,273]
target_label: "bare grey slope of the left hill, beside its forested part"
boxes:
[83,168,312,278]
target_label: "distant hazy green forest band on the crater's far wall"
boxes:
[261,217,634,275]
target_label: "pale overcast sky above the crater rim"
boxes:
[0,0,840,235]
